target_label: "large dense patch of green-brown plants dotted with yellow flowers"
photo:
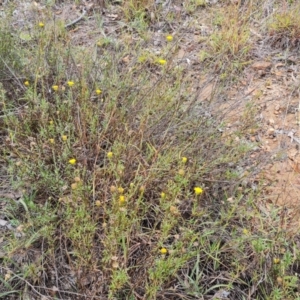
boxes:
[0,2,299,299]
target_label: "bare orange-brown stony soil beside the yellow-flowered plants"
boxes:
[11,1,300,219]
